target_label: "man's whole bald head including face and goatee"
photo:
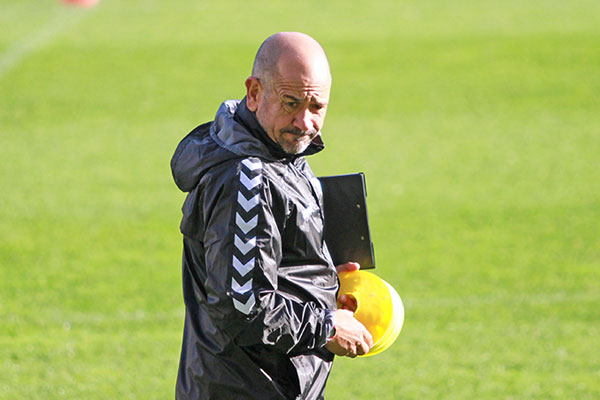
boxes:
[245,32,331,154]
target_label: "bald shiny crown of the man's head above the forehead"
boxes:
[252,32,331,86]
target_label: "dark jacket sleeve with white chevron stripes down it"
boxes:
[201,158,333,353]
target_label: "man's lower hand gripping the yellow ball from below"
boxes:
[325,310,373,358]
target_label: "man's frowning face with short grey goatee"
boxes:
[246,61,331,154]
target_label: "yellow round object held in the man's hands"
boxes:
[338,270,404,357]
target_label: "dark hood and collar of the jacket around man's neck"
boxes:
[171,98,324,192]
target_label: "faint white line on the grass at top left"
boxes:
[0,10,89,79]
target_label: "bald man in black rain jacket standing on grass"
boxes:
[171,32,373,400]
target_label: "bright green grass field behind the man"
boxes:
[0,0,600,400]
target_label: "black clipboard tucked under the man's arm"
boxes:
[319,172,375,269]
